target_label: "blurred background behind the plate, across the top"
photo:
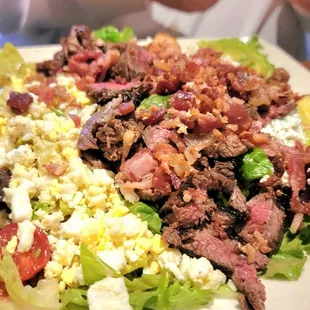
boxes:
[0,0,310,60]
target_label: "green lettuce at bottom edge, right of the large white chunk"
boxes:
[126,272,215,310]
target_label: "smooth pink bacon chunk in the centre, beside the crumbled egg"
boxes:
[120,149,155,181]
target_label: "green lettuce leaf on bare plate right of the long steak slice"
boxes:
[265,233,307,281]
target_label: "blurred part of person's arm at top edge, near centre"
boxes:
[153,0,218,12]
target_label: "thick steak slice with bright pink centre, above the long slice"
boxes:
[239,193,285,251]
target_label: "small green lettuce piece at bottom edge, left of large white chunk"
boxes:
[60,288,88,310]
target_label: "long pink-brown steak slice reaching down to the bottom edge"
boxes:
[170,226,268,310]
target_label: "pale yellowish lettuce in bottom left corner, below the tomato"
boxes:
[0,251,61,310]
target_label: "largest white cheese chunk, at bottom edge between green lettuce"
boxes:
[87,278,132,310]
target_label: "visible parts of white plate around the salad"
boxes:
[19,39,310,310]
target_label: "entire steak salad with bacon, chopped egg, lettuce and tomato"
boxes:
[0,26,310,310]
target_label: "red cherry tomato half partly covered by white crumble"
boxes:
[0,223,51,281]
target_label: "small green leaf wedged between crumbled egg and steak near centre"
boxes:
[128,202,162,233]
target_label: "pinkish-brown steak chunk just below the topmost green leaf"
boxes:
[112,44,153,81]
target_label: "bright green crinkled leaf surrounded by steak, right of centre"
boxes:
[241,148,273,180]
